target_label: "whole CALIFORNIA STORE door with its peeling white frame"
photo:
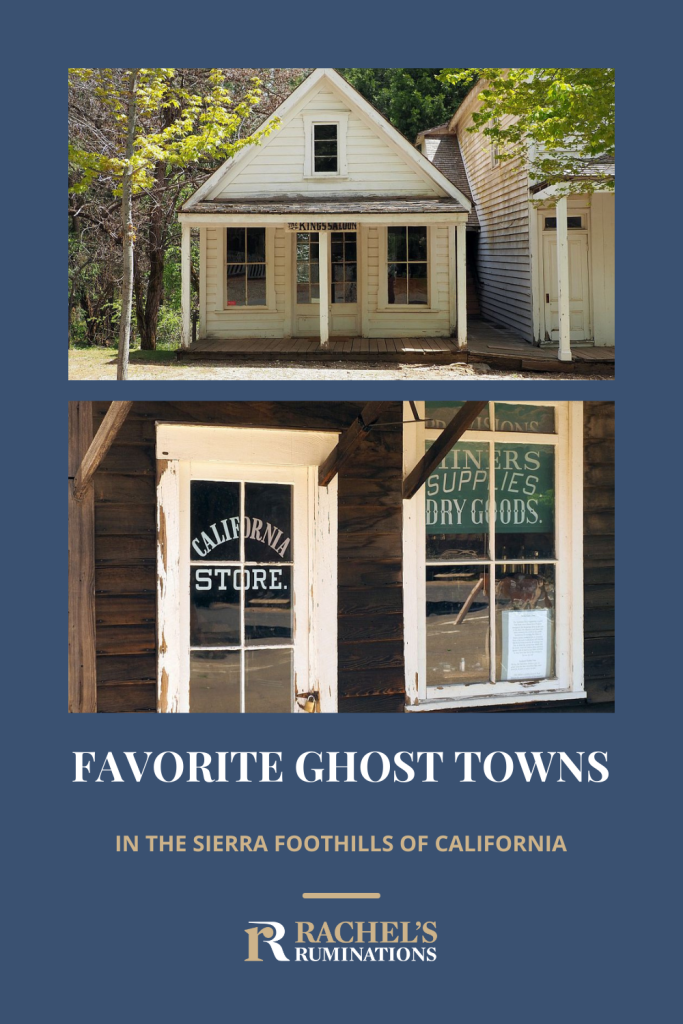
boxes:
[157,425,338,714]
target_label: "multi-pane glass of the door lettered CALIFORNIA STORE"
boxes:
[189,479,295,713]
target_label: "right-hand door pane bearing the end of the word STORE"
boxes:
[244,565,293,647]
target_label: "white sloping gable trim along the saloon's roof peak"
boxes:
[183,68,472,212]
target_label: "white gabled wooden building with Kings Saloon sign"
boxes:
[180,68,472,349]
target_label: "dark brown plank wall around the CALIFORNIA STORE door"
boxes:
[93,402,404,713]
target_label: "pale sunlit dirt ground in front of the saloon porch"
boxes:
[69,348,611,382]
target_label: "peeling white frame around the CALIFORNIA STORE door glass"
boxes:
[157,423,339,714]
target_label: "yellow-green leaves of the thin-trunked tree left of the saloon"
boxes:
[69,68,278,195]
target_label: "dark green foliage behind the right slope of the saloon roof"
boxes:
[337,68,469,142]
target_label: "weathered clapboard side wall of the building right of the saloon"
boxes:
[457,90,533,341]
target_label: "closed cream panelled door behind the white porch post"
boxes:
[543,231,592,342]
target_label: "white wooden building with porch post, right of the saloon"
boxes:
[418,76,614,360]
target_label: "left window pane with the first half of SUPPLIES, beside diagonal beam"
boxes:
[425,441,488,561]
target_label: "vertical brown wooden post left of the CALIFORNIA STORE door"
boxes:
[69,401,97,713]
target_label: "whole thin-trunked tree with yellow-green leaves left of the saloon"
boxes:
[69,68,276,380]
